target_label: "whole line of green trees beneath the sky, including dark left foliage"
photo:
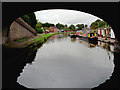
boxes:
[22,12,109,33]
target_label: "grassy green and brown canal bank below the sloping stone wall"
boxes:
[2,33,59,48]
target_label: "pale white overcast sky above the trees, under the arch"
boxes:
[35,9,100,26]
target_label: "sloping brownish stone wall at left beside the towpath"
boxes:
[8,17,37,41]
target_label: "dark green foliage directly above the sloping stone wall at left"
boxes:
[21,12,37,28]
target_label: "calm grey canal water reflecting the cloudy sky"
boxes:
[17,34,114,88]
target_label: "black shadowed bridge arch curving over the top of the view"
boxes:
[2,2,120,42]
